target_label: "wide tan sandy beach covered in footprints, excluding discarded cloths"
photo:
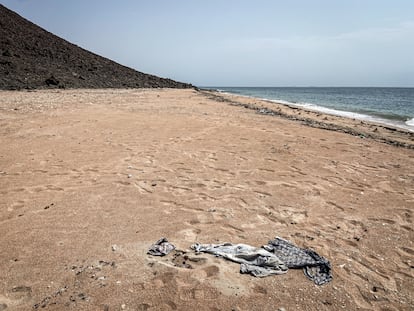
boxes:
[0,89,414,311]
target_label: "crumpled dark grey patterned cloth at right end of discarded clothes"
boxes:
[263,237,332,285]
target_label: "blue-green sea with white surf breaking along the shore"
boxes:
[208,87,414,132]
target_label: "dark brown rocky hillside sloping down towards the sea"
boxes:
[0,4,192,89]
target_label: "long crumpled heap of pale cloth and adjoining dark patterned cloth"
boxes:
[191,237,332,285]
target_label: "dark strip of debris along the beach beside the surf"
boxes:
[200,90,414,149]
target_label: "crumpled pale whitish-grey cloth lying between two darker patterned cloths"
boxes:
[191,243,288,277]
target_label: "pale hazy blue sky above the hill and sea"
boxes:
[0,0,414,87]
